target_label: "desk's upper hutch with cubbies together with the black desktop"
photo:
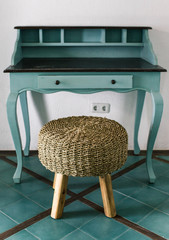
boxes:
[5,26,165,72]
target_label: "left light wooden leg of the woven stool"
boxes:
[51,173,68,219]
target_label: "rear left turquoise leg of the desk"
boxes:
[19,91,30,156]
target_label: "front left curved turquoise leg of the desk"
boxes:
[7,93,22,183]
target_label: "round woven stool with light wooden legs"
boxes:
[38,116,128,218]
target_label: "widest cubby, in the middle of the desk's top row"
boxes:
[64,29,102,43]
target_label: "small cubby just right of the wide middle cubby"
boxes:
[106,29,122,43]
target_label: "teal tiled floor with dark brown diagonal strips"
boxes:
[0,155,169,240]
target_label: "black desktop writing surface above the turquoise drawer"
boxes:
[4,58,167,73]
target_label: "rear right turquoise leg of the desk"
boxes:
[134,90,146,155]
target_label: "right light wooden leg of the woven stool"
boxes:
[99,174,116,218]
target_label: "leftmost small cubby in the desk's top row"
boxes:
[21,29,39,43]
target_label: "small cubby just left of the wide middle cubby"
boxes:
[43,29,61,43]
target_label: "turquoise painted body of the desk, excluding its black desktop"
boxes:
[4,27,166,183]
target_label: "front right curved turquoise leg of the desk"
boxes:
[146,92,163,183]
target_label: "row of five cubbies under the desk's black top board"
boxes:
[15,26,151,47]
